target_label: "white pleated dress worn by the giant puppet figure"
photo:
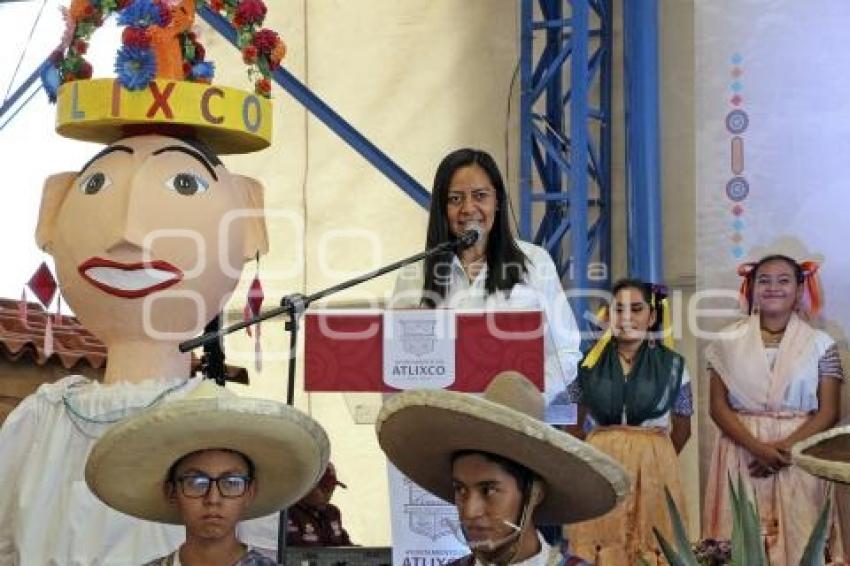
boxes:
[0,375,276,566]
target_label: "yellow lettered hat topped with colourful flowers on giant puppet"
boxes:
[52,0,286,154]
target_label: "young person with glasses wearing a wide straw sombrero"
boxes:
[85,381,329,566]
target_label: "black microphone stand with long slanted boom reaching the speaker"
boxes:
[179,228,481,564]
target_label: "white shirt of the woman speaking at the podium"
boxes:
[390,240,582,412]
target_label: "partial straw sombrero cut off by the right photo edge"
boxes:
[791,422,850,484]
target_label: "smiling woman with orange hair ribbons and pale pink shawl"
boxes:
[703,255,844,566]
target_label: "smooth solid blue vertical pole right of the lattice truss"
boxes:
[623,0,664,283]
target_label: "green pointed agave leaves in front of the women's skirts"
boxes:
[652,474,831,566]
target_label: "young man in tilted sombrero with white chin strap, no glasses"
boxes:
[376,372,629,566]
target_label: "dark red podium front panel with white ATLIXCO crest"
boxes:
[304,309,544,393]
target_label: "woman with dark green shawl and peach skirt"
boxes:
[566,279,693,566]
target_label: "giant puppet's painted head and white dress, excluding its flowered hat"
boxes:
[0,135,275,566]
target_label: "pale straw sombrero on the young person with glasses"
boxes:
[85,381,330,524]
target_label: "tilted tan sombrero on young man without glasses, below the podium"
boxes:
[376,372,629,524]
